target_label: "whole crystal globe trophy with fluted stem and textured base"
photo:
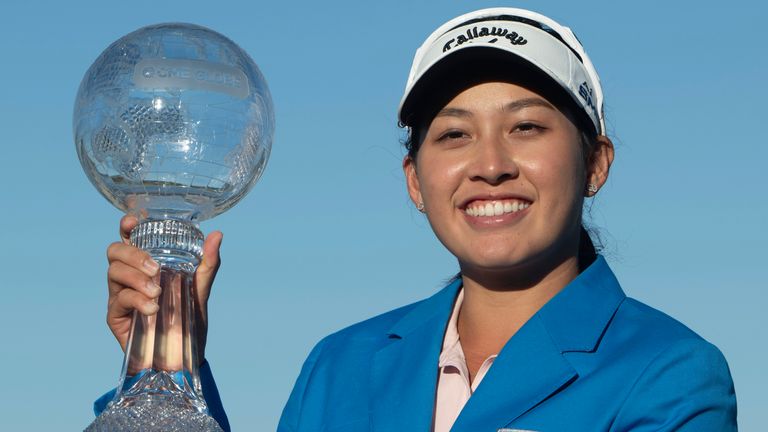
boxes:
[73,23,274,432]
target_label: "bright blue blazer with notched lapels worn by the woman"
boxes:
[278,257,737,432]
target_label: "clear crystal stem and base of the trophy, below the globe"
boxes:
[87,220,221,432]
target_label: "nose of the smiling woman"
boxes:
[469,133,520,185]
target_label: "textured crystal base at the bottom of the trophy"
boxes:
[85,399,224,432]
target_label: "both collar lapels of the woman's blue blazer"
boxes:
[370,256,625,432]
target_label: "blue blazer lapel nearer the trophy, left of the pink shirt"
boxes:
[369,279,461,432]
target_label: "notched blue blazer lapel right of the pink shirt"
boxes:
[451,256,626,432]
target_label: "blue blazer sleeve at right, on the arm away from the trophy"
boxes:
[611,338,737,432]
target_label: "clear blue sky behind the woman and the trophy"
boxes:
[0,0,768,431]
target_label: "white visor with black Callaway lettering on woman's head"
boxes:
[398,8,605,134]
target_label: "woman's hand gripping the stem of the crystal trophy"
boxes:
[107,215,223,361]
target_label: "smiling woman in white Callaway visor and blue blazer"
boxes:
[99,8,736,432]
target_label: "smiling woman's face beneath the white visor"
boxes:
[403,82,602,273]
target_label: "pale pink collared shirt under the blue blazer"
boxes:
[432,289,497,432]
